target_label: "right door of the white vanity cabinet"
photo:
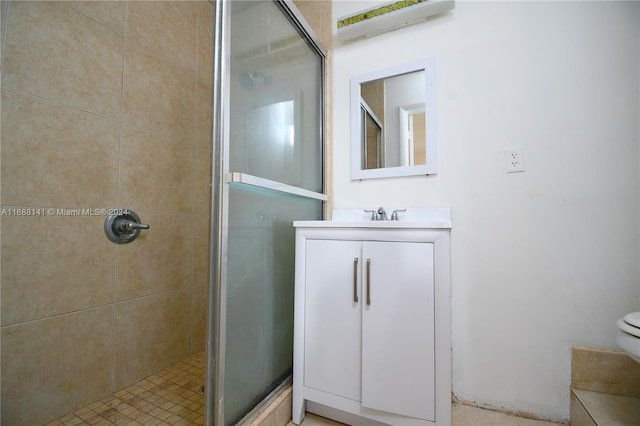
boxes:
[361,241,435,421]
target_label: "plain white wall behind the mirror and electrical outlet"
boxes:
[330,1,640,420]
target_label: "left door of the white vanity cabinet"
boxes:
[304,240,362,401]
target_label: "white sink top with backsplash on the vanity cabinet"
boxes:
[294,207,451,229]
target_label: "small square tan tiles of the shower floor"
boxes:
[45,352,205,426]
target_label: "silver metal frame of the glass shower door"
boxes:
[205,0,327,426]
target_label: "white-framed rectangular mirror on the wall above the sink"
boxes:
[351,58,437,180]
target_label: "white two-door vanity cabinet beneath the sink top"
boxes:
[293,221,451,426]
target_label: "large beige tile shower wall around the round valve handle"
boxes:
[0,1,214,425]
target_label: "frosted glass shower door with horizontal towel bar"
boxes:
[210,1,326,425]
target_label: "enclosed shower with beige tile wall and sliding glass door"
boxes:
[0,0,326,426]
